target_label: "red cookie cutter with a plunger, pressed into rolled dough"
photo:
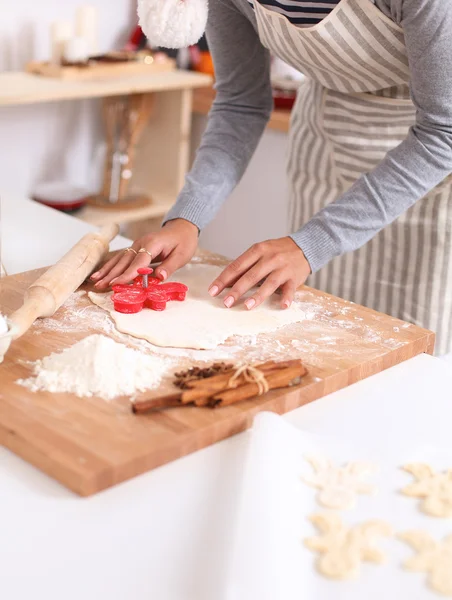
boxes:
[112,268,188,314]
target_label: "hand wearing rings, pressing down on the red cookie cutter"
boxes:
[91,219,198,289]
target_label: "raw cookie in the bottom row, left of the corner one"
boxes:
[304,513,392,579]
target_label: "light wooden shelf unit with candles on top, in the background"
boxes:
[0,70,212,225]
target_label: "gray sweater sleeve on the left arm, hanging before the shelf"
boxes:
[164,0,273,230]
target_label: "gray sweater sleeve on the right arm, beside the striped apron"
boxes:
[292,0,452,272]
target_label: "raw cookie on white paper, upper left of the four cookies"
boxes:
[301,456,377,510]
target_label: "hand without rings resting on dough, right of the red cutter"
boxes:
[209,237,311,310]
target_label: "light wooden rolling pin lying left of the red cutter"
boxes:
[9,225,119,340]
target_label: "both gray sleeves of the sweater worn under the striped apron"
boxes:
[165,0,452,272]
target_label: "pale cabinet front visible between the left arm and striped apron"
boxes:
[193,116,288,258]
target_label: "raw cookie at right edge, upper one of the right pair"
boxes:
[402,463,452,518]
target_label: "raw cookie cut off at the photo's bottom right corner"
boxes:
[397,531,452,596]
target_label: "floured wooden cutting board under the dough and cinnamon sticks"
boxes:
[0,258,434,496]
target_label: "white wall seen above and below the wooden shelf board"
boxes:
[0,0,136,195]
